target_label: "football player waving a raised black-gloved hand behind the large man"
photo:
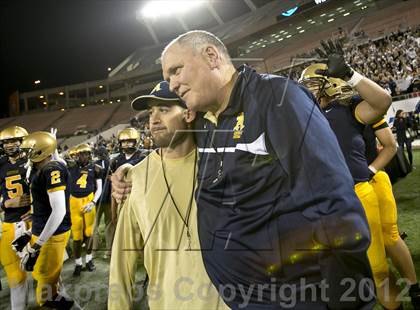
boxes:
[300,41,401,309]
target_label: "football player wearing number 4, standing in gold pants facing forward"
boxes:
[68,143,102,277]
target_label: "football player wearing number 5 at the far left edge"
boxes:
[0,126,31,310]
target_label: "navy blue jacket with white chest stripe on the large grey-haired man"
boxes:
[196,66,374,309]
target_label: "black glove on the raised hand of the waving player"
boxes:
[315,40,354,81]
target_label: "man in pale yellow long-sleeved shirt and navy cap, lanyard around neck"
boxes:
[108,82,228,310]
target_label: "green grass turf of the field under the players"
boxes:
[0,150,420,310]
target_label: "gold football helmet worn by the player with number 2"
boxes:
[21,131,57,163]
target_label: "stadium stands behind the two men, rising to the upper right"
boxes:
[0,0,420,151]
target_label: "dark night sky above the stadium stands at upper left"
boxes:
[0,0,153,117]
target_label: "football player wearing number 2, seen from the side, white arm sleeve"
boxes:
[18,131,73,309]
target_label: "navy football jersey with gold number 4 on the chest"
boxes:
[69,163,103,198]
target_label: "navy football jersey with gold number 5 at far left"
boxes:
[0,159,31,223]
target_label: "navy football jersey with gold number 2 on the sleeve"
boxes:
[31,161,71,236]
